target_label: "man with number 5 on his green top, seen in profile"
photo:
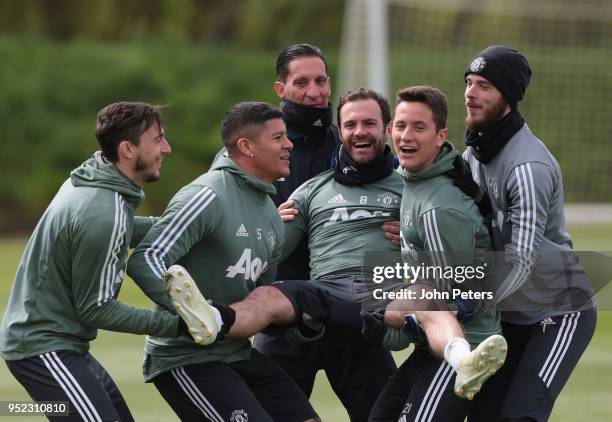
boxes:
[128,102,317,422]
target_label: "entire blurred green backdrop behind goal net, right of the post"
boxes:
[372,0,612,202]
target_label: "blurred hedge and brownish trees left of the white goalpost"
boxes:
[0,0,343,234]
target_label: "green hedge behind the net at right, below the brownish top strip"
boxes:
[390,43,612,202]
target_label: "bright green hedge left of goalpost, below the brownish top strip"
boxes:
[0,38,333,232]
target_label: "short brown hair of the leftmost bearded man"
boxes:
[96,101,163,163]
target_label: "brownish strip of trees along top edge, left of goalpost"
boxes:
[0,0,344,50]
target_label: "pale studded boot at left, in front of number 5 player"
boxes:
[164,265,220,346]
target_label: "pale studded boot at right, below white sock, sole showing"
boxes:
[455,334,508,400]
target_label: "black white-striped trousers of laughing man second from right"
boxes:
[369,347,473,422]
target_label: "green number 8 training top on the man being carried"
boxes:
[283,170,403,280]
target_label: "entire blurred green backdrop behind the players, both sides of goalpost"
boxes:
[0,0,612,234]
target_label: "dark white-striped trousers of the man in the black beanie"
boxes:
[468,310,597,422]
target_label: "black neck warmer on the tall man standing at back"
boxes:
[280,100,332,149]
